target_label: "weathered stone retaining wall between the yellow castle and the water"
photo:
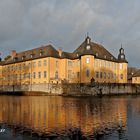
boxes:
[0,84,140,96]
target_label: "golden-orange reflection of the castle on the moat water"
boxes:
[0,96,127,135]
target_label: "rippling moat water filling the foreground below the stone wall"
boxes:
[0,96,140,140]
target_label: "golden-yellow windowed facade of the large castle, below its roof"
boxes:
[0,55,127,85]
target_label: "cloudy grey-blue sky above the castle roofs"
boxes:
[0,0,140,67]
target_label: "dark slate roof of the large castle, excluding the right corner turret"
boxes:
[2,36,127,65]
